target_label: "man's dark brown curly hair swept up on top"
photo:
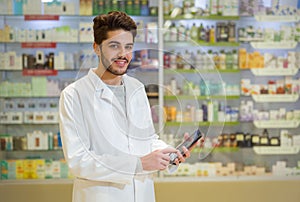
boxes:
[93,11,137,45]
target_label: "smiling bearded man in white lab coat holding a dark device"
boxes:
[59,11,190,202]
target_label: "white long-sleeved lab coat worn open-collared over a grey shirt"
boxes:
[59,69,167,202]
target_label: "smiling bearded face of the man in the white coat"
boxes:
[100,30,133,76]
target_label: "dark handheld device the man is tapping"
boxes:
[170,128,203,165]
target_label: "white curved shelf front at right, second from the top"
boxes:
[250,41,298,50]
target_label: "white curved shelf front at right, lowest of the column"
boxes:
[253,146,300,155]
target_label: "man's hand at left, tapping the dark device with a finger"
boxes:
[141,147,184,171]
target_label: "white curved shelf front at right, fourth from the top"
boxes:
[252,94,299,102]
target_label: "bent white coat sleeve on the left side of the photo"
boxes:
[59,88,138,184]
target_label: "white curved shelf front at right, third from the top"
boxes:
[251,68,298,76]
